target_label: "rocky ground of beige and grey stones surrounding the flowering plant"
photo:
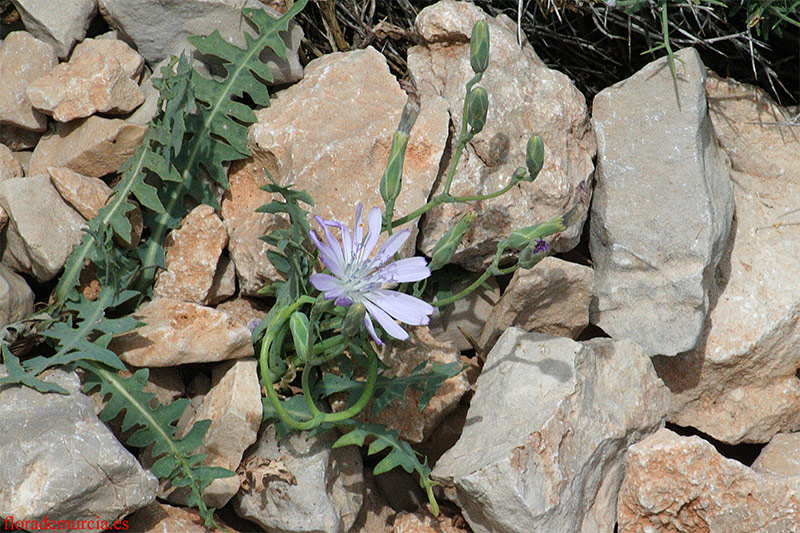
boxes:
[0,0,800,533]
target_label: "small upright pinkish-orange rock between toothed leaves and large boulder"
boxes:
[153,205,228,304]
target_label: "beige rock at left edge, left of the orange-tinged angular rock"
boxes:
[0,31,58,131]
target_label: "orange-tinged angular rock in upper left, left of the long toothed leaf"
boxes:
[27,41,144,122]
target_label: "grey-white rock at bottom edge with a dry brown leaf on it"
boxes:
[234,426,364,533]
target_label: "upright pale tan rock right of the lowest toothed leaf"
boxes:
[159,358,261,509]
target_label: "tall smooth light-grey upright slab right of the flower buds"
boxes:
[589,48,734,355]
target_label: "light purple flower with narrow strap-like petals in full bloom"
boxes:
[309,204,433,344]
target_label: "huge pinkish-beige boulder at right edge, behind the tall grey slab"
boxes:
[654,72,800,443]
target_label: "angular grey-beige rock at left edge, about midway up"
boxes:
[0,176,86,281]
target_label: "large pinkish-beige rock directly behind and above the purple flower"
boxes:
[234,48,447,294]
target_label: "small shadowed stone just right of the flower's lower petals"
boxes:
[428,274,500,351]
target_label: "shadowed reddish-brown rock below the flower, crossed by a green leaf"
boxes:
[364,326,469,442]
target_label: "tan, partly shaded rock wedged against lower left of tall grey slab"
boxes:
[479,257,594,350]
